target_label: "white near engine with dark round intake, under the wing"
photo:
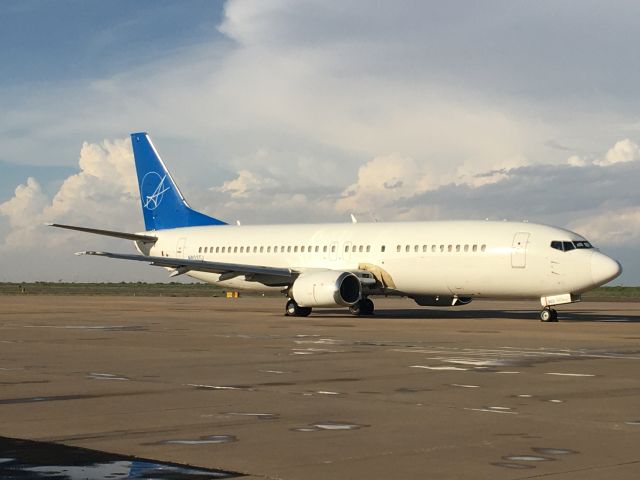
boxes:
[289,270,362,307]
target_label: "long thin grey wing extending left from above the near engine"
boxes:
[76,251,297,278]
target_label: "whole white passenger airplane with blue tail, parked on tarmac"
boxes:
[48,132,622,322]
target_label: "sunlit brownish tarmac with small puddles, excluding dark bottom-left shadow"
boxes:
[0,295,640,480]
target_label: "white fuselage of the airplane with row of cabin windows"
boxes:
[142,221,619,298]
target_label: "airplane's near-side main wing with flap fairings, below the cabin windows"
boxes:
[76,251,299,286]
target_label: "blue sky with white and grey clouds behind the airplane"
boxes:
[0,0,640,284]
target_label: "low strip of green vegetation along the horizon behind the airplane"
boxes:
[0,282,640,301]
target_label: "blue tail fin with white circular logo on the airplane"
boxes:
[131,132,226,230]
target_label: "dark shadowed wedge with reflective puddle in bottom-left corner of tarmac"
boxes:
[0,437,244,480]
